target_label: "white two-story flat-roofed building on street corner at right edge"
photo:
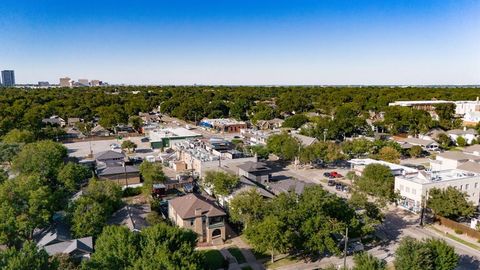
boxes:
[395,169,480,213]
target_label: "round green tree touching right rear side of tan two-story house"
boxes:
[229,189,266,226]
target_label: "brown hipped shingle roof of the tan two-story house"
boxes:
[169,193,226,219]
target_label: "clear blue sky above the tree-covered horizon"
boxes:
[0,0,480,85]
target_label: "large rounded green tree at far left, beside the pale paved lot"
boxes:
[12,141,67,182]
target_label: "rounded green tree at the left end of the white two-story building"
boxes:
[355,164,396,205]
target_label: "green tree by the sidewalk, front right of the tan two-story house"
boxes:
[245,216,289,263]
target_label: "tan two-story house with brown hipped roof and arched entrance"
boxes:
[168,193,226,244]
